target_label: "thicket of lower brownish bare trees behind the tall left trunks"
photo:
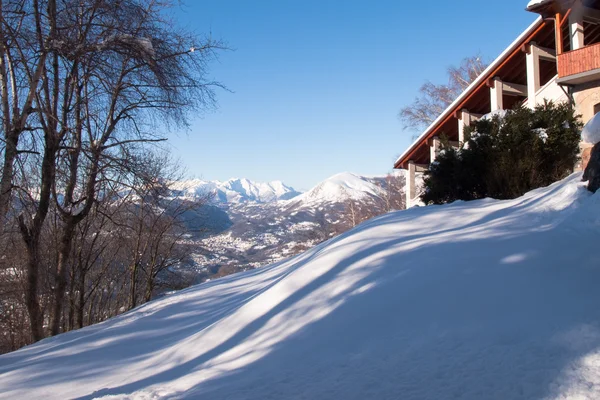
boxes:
[0,146,210,353]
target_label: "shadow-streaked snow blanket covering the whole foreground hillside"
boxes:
[0,173,600,400]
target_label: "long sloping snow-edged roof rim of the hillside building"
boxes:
[396,17,544,164]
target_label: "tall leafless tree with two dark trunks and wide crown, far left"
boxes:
[0,0,222,340]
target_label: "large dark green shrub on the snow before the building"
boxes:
[421,102,582,204]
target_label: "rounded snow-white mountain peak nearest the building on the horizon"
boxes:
[289,172,383,205]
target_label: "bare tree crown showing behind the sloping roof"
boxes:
[398,54,487,129]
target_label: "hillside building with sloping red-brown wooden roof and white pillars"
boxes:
[394,0,600,207]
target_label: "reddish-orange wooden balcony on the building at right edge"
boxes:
[557,43,600,85]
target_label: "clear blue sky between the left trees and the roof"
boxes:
[170,0,535,189]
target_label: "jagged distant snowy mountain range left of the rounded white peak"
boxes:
[174,178,299,203]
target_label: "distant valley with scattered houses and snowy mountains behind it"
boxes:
[174,172,404,282]
